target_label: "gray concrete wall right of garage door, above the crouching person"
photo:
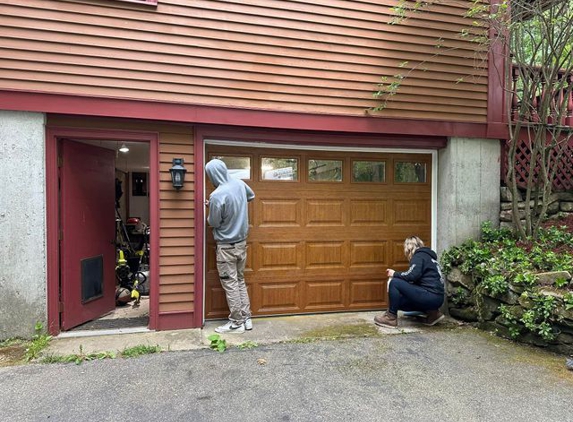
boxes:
[437,138,501,254]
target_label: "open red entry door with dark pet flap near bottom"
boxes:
[60,140,115,330]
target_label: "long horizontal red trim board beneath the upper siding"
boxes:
[0,90,487,138]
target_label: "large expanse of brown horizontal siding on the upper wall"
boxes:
[0,0,487,123]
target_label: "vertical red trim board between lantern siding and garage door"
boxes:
[193,132,206,327]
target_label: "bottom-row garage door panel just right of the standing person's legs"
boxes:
[253,281,303,314]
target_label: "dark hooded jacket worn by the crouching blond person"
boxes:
[394,248,444,295]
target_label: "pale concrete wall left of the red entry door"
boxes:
[0,111,46,340]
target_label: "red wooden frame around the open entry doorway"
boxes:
[46,126,159,335]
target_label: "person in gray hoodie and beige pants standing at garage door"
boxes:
[205,159,255,334]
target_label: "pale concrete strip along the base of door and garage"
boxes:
[43,311,428,356]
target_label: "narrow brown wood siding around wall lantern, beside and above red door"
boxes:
[48,116,195,317]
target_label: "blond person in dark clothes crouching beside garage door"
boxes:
[374,236,444,328]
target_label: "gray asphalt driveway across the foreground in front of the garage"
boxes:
[0,326,573,422]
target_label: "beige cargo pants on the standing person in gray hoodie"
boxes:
[217,241,251,324]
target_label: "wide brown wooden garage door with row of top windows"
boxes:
[205,146,432,318]
